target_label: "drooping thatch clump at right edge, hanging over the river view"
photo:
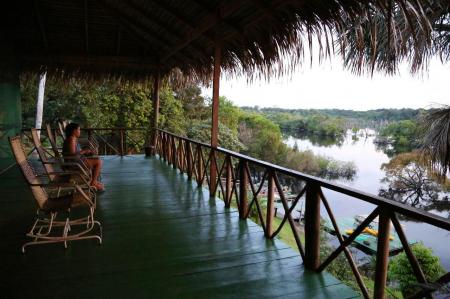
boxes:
[421,106,450,177]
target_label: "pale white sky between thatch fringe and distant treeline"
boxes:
[203,57,450,111]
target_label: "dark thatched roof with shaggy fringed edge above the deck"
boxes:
[2,0,448,79]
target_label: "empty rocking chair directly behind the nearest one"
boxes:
[31,128,92,186]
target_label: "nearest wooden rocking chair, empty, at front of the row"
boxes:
[9,136,102,253]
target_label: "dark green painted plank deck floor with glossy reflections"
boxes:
[0,156,357,298]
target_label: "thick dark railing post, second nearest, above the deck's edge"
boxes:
[305,182,320,270]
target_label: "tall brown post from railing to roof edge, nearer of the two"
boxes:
[209,32,222,196]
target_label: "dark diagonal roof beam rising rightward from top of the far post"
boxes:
[161,0,247,63]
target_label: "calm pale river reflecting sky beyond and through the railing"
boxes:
[285,134,450,271]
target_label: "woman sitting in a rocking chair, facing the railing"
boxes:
[63,123,104,191]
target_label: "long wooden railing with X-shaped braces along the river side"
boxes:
[156,130,450,298]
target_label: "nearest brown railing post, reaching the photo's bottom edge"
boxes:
[373,208,391,299]
